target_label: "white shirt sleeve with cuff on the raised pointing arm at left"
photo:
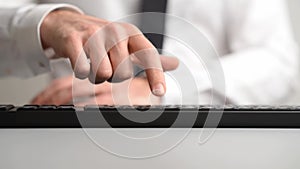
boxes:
[0,4,82,77]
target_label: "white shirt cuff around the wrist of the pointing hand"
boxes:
[12,4,83,76]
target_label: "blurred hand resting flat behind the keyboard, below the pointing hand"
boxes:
[31,76,160,106]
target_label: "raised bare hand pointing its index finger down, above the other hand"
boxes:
[40,10,178,96]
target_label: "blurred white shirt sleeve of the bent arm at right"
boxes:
[221,0,299,104]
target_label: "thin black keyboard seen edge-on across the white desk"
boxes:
[0,105,300,128]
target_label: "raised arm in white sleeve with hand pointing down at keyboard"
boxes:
[1,4,178,96]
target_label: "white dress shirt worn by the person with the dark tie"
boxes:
[0,0,298,104]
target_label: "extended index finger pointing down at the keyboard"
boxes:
[128,34,166,96]
